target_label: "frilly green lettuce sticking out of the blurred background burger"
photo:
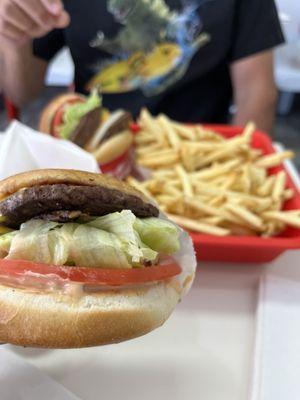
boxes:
[58,90,102,139]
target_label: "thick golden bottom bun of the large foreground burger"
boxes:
[0,280,180,348]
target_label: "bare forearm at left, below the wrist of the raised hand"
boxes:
[1,42,46,107]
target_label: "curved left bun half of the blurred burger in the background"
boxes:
[39,93,85,135]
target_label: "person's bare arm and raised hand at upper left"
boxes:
[0,0,69,106]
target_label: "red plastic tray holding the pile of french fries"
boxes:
[191,125,300,263]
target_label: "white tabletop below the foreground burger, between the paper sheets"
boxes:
[3,264,261,400]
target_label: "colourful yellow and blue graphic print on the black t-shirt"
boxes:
[87,0,209,96]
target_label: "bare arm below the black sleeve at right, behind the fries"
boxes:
[231,50,277,133]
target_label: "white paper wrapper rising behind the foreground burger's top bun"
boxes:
[0,121,99,179]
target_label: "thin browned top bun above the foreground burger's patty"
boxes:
[0,169,149,203]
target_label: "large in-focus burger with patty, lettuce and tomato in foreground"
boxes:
[0,169,195,348]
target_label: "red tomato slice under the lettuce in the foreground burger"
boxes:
[0,258,181,286]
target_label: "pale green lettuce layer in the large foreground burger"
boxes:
[0,210,179,268]
